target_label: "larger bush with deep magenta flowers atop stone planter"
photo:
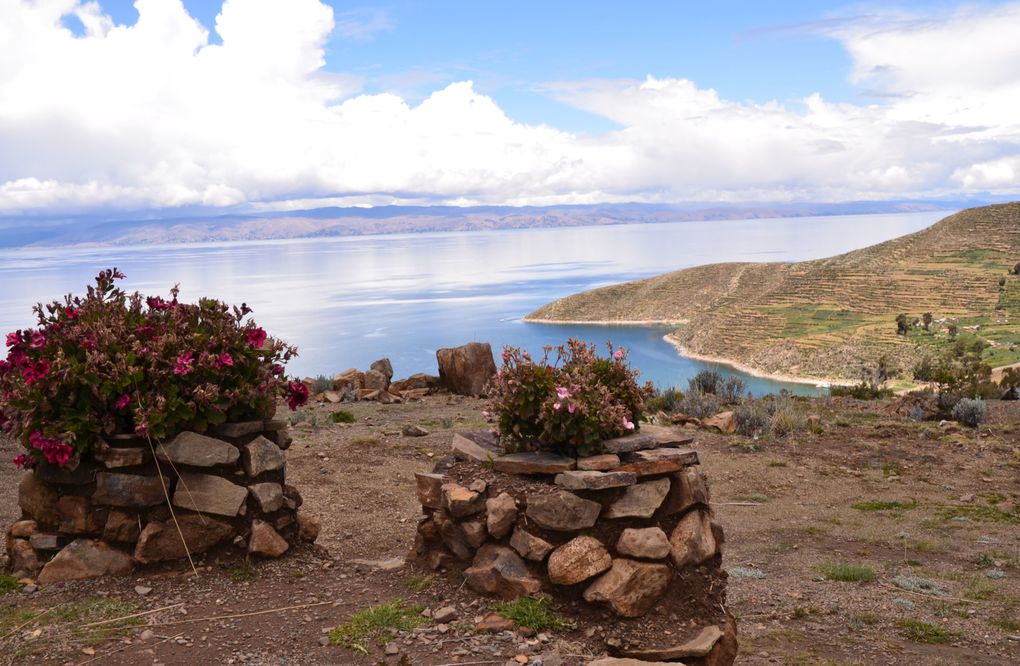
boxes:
[0,269,308,467]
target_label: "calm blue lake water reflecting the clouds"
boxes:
[0,213,949,394]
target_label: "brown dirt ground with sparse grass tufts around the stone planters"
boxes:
[0,396,1020,666]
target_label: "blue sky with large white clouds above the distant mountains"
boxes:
[0,0,1020,217]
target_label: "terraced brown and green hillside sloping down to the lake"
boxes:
[527,202,1020,379]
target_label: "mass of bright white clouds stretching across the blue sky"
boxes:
[0,0,1020,213]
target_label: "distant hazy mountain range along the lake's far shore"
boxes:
[0,201,987,248]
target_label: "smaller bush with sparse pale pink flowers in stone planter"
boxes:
[489,339,654,455]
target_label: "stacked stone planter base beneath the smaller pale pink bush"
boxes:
[415,425,736,666]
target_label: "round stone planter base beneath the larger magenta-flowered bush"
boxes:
[7,420,318,582]
